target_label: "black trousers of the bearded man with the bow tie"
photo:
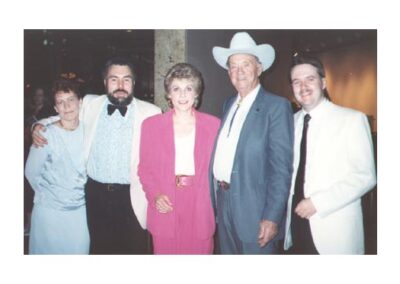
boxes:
[85,178,150,254]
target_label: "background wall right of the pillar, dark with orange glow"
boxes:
[186,30,377,131]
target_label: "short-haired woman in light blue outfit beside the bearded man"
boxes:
[25,80,89,254]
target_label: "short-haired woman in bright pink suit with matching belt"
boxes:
[138,63,220,254]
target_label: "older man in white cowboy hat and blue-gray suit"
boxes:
[210,32,293,254]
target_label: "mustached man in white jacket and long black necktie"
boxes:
[284,57,376,254]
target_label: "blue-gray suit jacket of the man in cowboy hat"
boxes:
[210,87,294,242]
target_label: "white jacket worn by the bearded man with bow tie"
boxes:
[39,95,161,229]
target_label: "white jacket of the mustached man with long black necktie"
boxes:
[284,100,376,254]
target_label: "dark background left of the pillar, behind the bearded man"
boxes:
[24,29,154,101]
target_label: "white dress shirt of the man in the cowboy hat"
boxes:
[213,84,260,183]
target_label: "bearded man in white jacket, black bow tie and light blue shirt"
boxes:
[33,58,161,254]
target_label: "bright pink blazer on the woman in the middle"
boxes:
[138,110,220,239]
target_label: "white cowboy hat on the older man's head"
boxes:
[213,32,275,71]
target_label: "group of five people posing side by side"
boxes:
[25,32,376,254]
